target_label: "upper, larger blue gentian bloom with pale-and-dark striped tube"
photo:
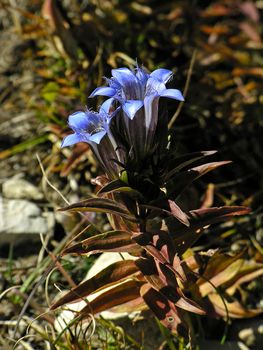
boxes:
[90,67,184,159]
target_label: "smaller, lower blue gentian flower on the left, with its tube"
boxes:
[61,99,123,178]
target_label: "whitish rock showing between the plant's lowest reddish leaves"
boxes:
[55,253,139,332]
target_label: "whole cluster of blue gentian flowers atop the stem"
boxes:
[62,67,184,178]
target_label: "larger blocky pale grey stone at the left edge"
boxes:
[0,196,55,244]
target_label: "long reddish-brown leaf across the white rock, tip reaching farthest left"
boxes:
[51,260,138,310]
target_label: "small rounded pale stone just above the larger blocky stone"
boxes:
[2,176,43,200]
